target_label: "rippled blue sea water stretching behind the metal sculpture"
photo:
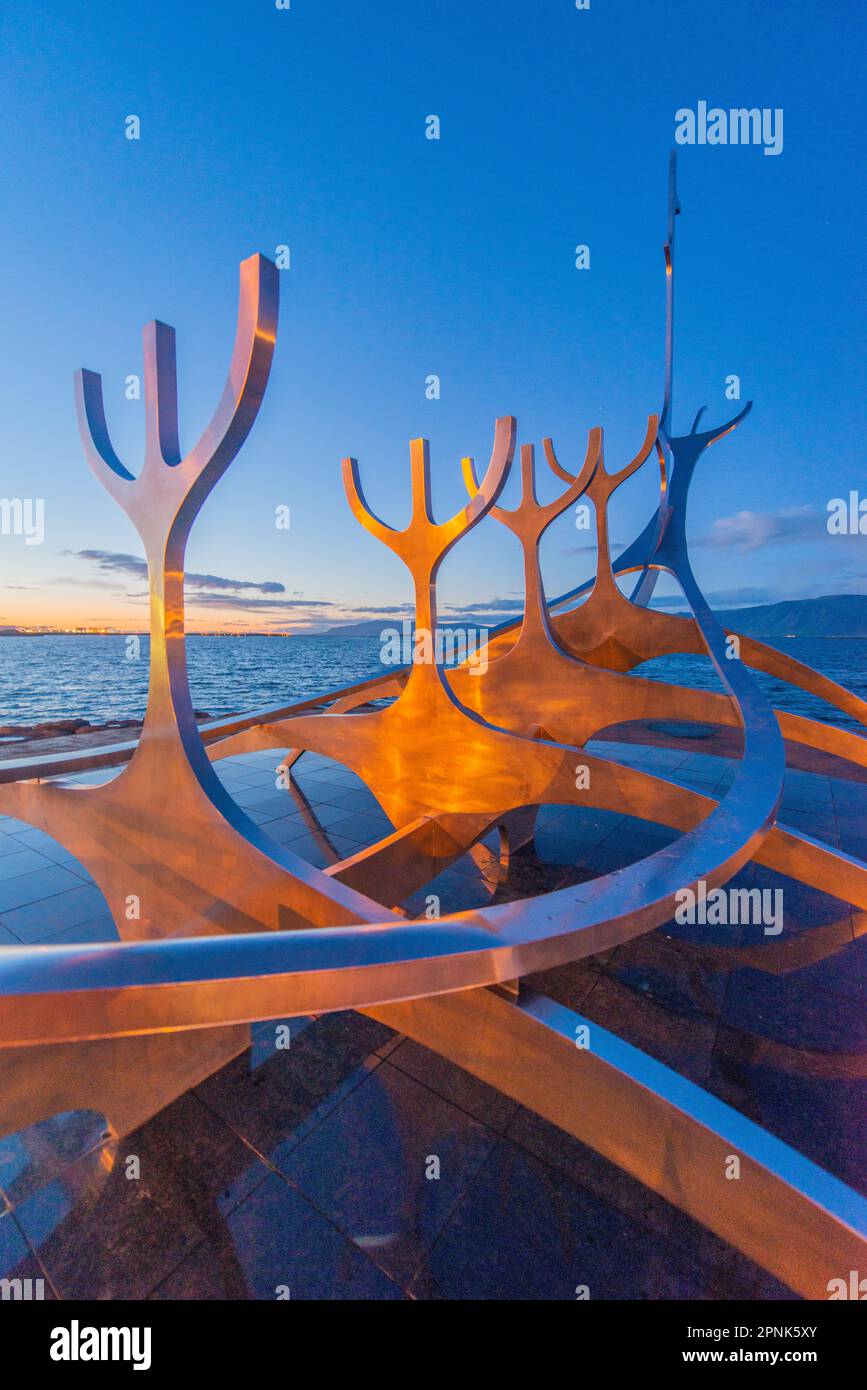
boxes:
[0,635,867,730]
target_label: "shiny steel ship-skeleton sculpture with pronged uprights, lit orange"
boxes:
[0,161,867,1297]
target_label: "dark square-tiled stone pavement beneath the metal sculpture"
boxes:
[0,742,867,1300]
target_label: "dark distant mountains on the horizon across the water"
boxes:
[323,594,867,641]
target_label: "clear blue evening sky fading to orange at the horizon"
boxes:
[0,0,867,630]
